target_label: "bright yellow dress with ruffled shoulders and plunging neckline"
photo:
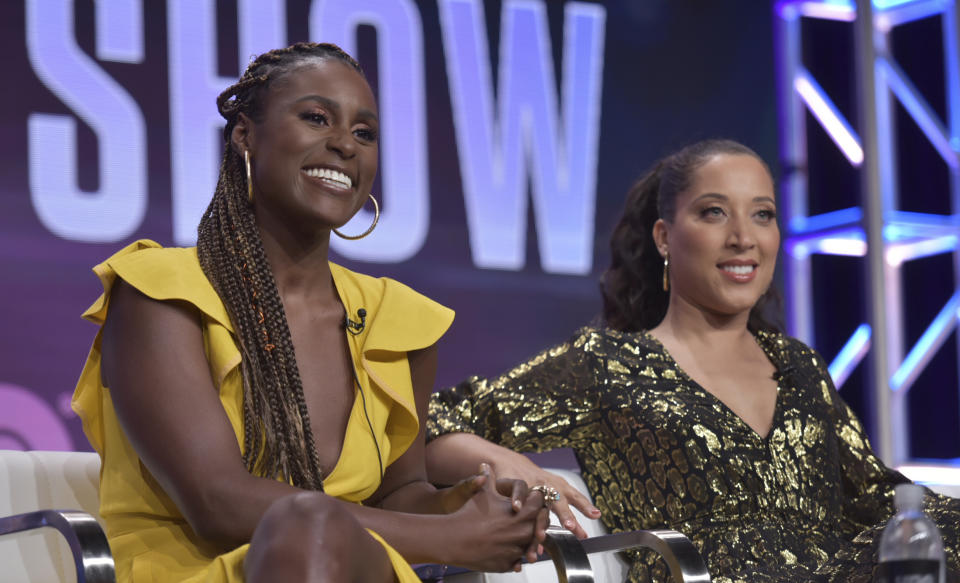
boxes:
[73,240,453,583]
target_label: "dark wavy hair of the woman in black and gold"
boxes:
[600,140,783,332]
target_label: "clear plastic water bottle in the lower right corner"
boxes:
[874,484,946,583]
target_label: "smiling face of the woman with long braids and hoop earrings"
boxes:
[232,58,379,231]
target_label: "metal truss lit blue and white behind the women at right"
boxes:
[775,0,960,472]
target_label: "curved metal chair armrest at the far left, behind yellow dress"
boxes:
[0,510,116,583]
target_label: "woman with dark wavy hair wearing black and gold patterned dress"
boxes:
[427,140,960,583]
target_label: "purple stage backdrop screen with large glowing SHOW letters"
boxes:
[0,0,844,460]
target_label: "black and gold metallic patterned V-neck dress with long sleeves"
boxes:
[427,328,960,583]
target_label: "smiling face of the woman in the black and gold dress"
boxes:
[654,154,780,317]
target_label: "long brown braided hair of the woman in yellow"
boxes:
[197,43,362,490]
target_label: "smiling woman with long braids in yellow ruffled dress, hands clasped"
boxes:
[73,43,546,583]
